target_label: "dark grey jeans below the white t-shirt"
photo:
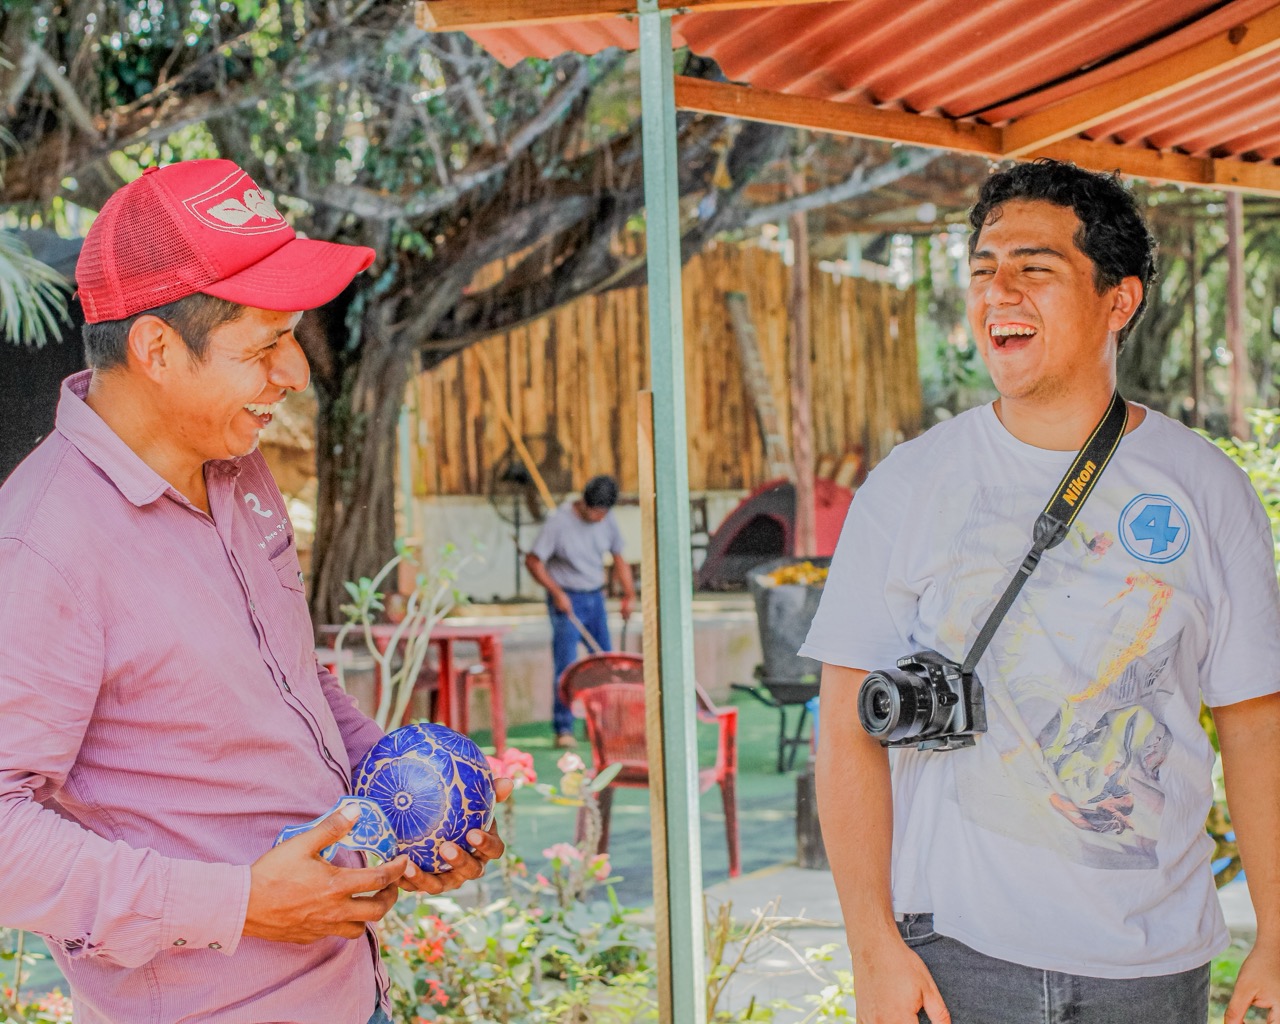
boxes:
[897,914,1208,1024]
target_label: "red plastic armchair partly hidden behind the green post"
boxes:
[559,652,742,878]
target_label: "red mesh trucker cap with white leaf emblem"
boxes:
[76,160,374,324]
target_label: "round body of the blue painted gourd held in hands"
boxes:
[352,723,494,874]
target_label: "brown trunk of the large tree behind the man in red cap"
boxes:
[311,301,410,623]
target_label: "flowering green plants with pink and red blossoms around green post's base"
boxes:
[381,749,852,1024]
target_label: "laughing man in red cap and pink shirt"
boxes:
[0,160,509,1024]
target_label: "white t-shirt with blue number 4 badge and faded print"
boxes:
[800,406,1280,978]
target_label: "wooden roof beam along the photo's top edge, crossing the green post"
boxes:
[413,0,832,32]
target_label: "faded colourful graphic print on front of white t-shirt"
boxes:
[940,489,1181,869]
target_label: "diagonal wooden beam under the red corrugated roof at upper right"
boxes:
[1005,5,1280,157]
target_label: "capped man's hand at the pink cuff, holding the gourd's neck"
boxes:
[244,805,412,942]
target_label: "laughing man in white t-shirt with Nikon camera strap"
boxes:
[801,161,1280,1024]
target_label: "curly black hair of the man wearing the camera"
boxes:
[969,159,1156,344]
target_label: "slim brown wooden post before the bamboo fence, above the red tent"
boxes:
[790,174,818,558]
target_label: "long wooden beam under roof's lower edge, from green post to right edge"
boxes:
[676,76,1280,196]
